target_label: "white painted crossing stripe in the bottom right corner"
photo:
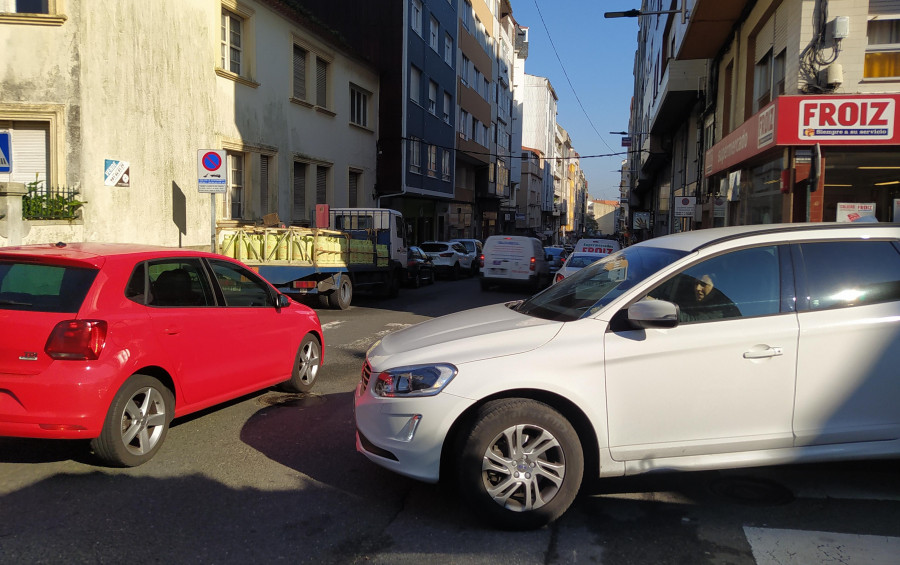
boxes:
[744,526,900,565]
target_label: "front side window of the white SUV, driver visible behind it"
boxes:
[650,246,780,323]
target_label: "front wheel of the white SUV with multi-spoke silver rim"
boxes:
[457,398,584,530]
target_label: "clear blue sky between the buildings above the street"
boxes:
[510,0,641,200]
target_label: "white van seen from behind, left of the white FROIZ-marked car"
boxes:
[481,235,550,292]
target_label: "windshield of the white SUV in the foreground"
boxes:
[515,246,687,322]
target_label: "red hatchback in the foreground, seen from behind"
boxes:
[0,243,324,467]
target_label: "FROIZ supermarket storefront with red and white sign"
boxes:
[701,94,900,227]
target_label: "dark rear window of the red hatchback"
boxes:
[0,261,97,313]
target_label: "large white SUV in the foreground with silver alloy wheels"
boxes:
[354,223,900,528]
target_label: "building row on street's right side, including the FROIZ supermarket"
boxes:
[623,0,900,240]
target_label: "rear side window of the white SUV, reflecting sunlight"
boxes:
[797,241,900,310]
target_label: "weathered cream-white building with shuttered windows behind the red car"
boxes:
[0,0,379,247]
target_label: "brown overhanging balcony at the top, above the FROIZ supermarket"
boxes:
[677,0,750,61]
